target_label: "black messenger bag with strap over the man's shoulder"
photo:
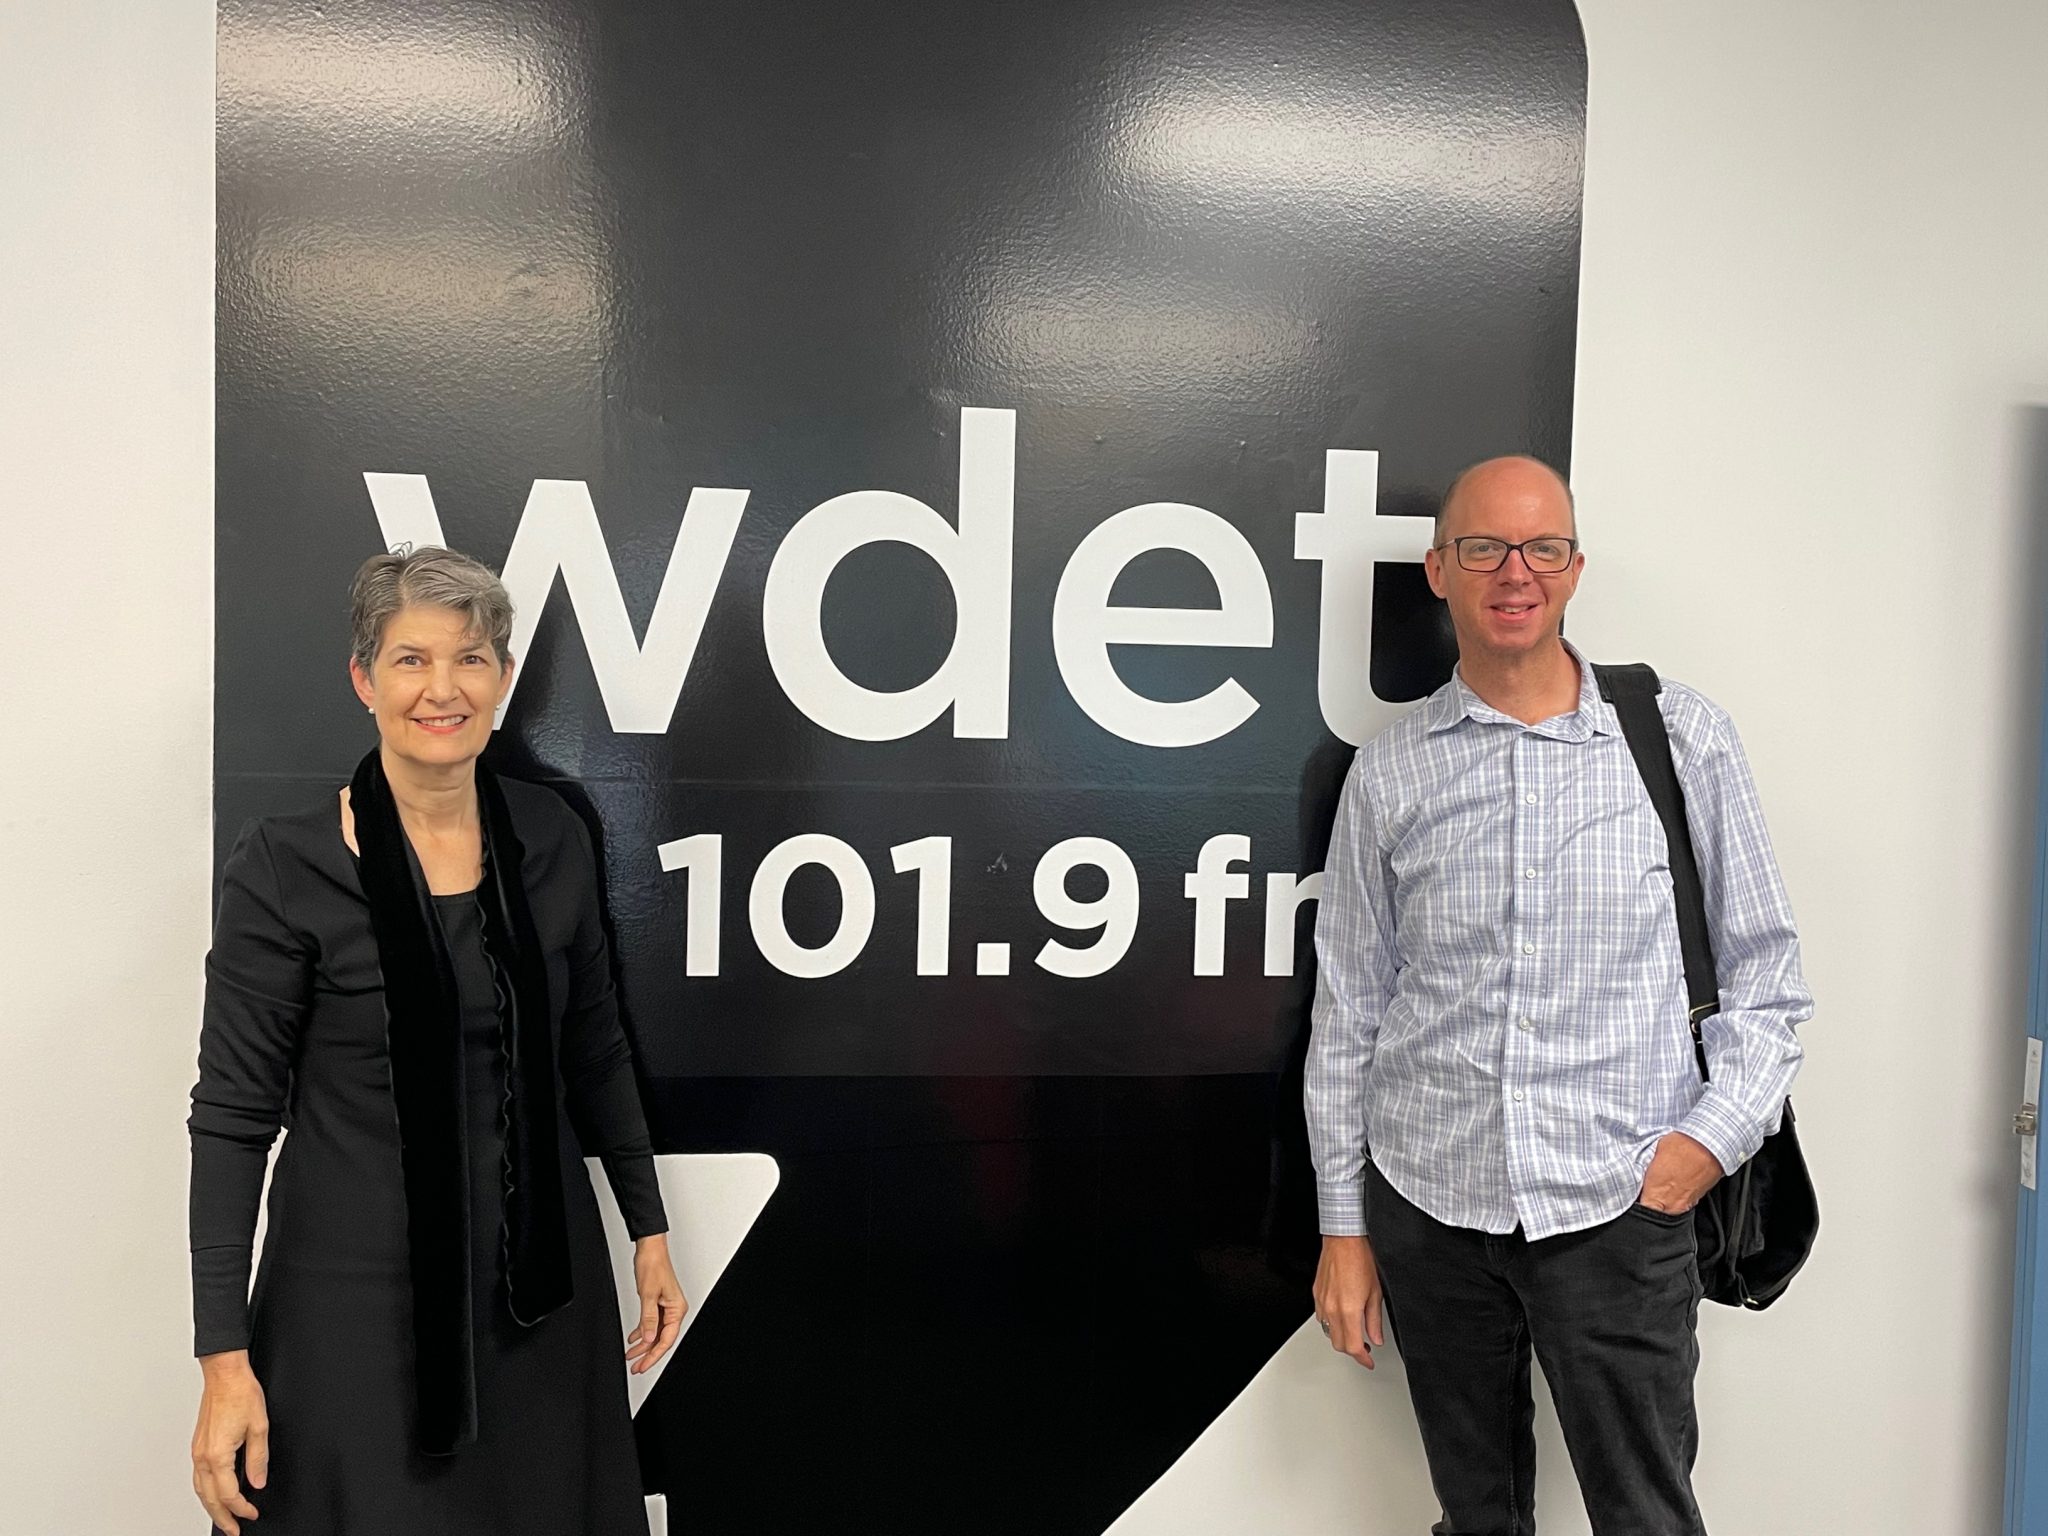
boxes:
[1593,662,1821,1313]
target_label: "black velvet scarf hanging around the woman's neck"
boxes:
[348,750,571,1456]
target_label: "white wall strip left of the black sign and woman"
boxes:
[0,0,214,1536]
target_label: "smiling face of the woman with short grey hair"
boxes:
[348,604,512,768]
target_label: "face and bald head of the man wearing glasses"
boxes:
[1423,459,1585,659]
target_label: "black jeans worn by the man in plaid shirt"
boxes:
[1366,1163,1706,1536]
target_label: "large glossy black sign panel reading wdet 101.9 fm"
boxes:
[215,0,1585,1536]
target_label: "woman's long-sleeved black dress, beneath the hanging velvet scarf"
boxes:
[190,782,666,1536]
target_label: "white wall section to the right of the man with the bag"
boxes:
[1575,0,2048,1536]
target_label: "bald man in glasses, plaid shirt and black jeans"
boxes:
[1307,457,1812,1536]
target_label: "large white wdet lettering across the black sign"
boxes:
[362,406,1430,748]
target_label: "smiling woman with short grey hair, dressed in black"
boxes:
[190,549,684,1536]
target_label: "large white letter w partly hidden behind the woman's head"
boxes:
[362,473,748,735]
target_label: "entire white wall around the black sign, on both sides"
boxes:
[0,0,2048,1536]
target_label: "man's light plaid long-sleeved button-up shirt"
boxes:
[1307,651,1812,1239]
